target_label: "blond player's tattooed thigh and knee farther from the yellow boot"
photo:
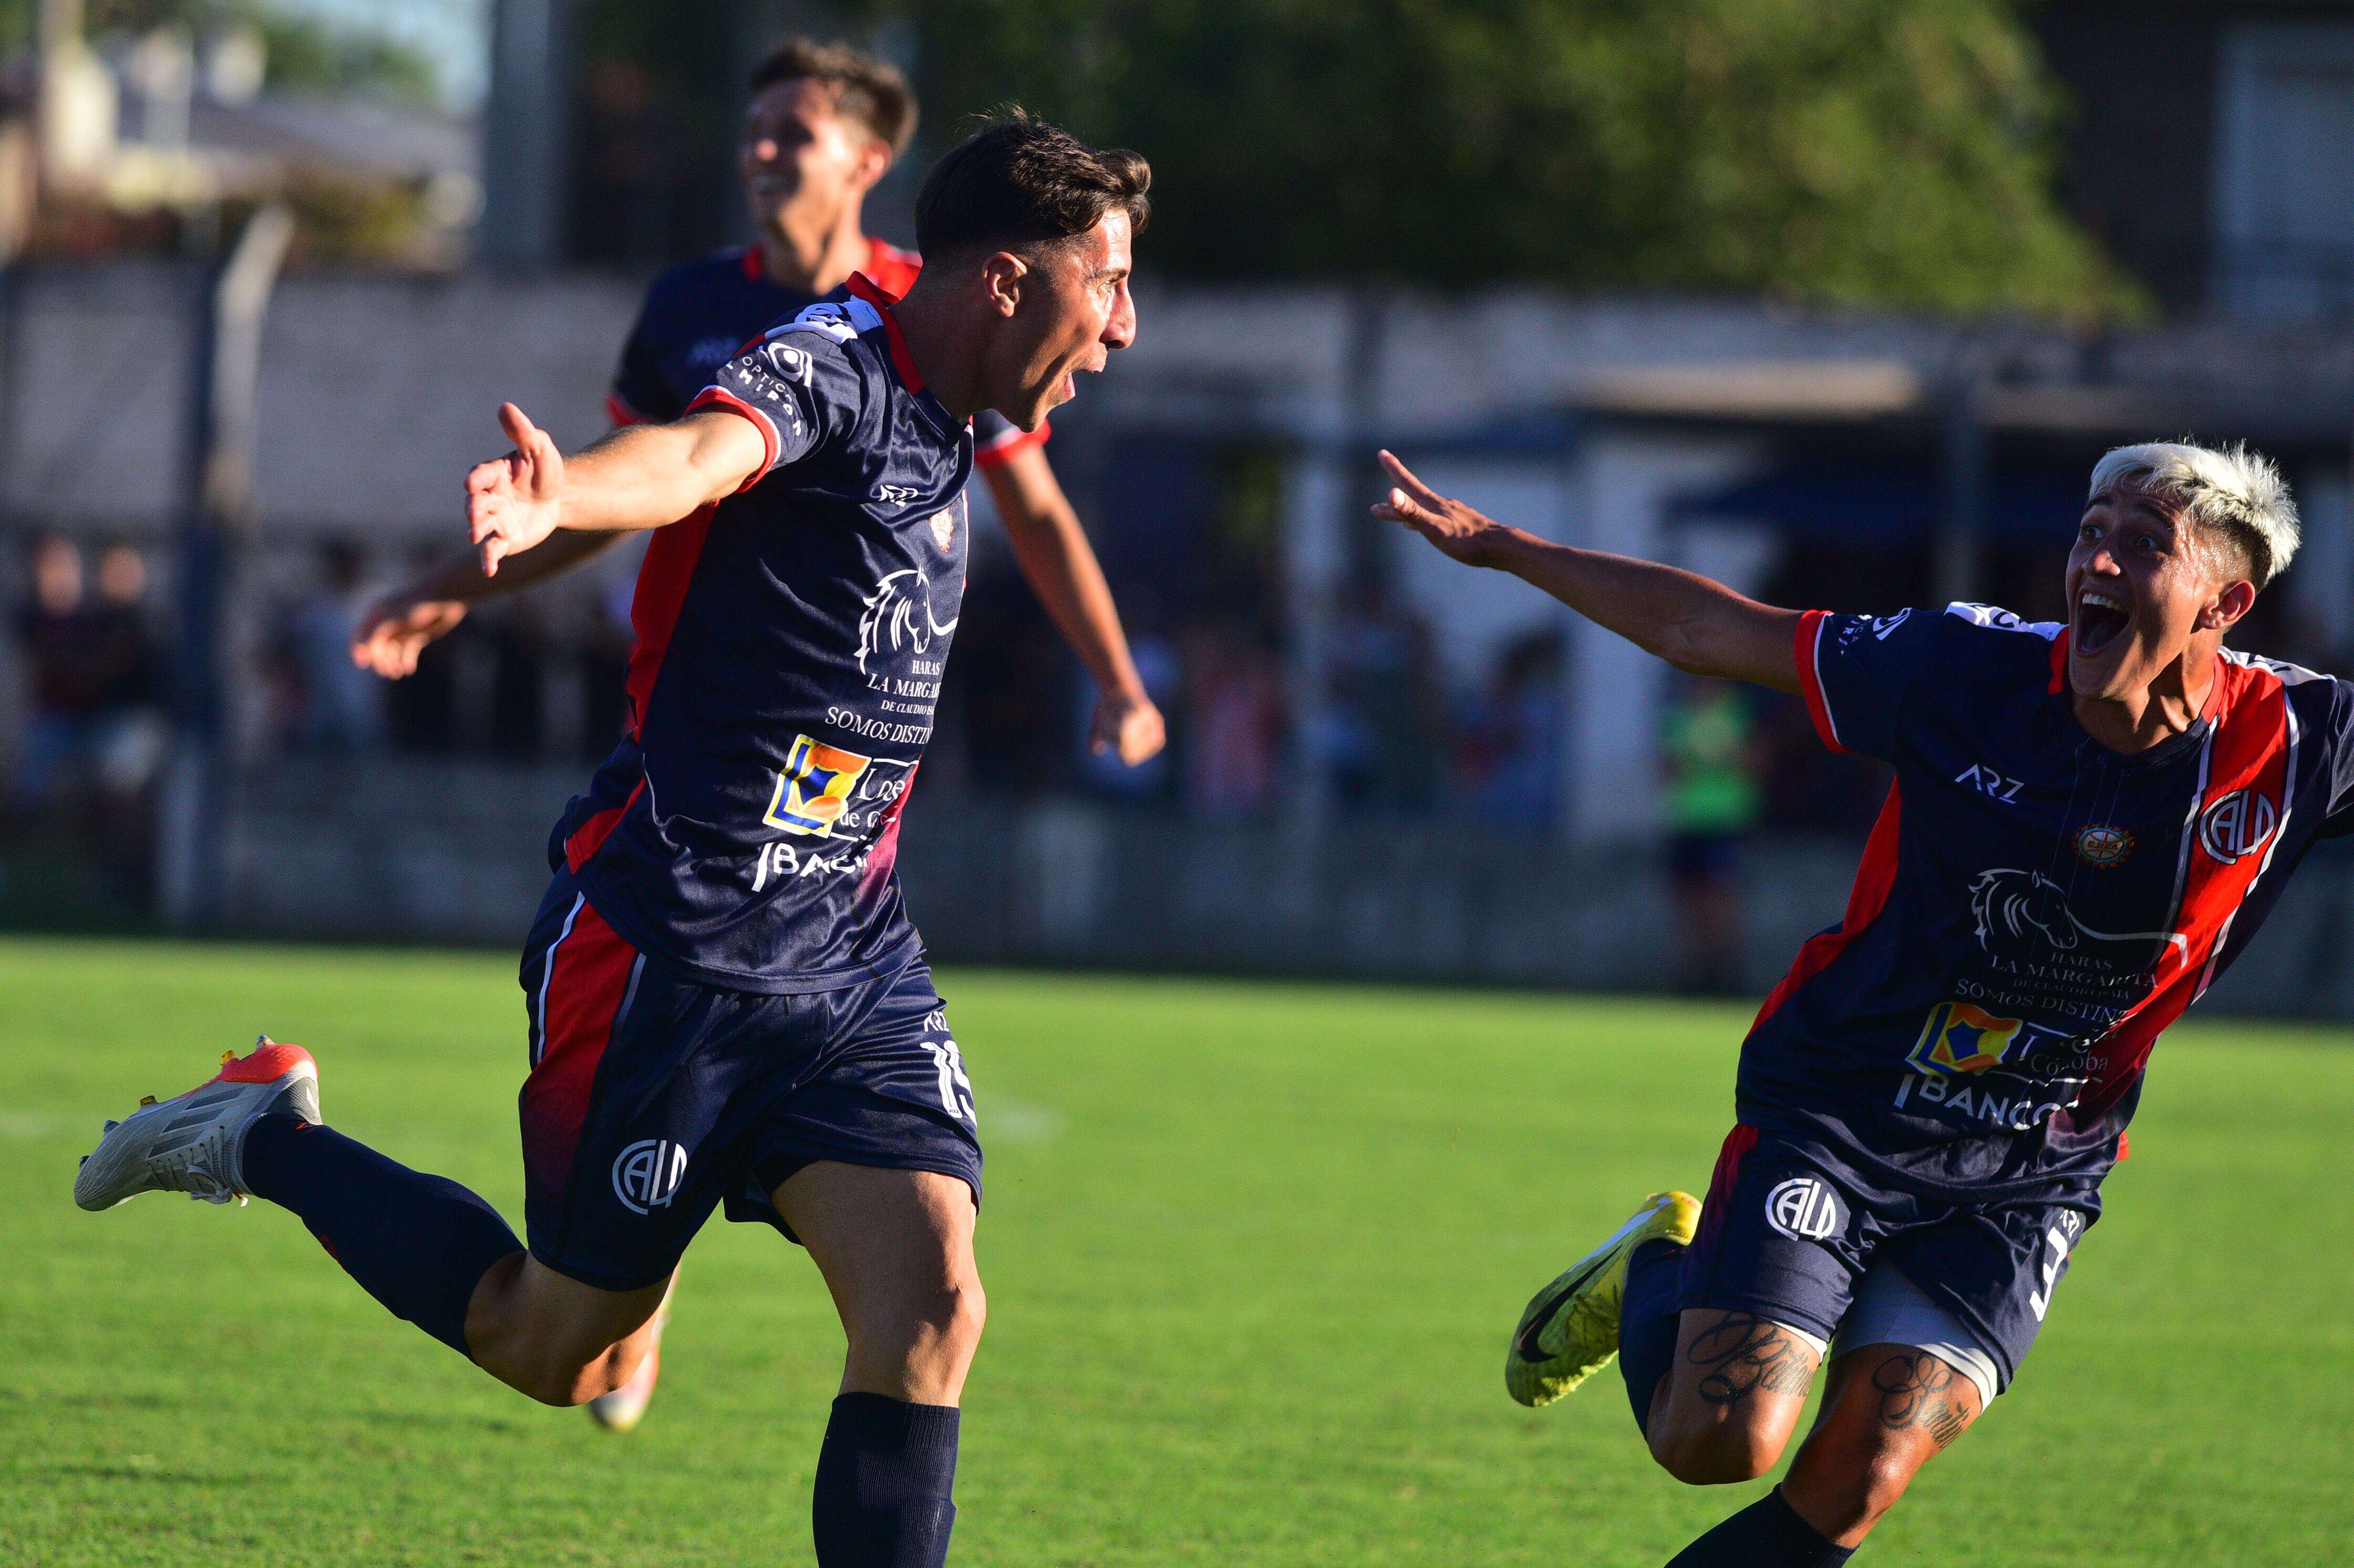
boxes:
[1782,1344,1982,1547]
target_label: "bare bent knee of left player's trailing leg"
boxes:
[466,1253,671,1406]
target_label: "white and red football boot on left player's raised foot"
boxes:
[73,1036,320,1210]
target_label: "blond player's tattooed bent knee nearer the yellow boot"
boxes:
[1646,1307,1822,1486]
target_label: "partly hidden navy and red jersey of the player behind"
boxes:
[605,240,1048,466]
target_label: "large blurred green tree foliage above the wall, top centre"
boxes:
[854,0,2138,315]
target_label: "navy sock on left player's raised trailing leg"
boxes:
[245,1116,523,1361]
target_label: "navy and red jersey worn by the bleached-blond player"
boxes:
[1737,605,2354,1212]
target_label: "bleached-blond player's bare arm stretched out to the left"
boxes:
[1372,452,1799,692]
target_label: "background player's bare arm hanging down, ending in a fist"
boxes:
[982,447,1168,768]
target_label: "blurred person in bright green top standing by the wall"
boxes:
[1662,678,1759,994]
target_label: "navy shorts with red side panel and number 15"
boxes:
[523,876,982,1290]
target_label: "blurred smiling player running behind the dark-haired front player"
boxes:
[351,38,1163,1431]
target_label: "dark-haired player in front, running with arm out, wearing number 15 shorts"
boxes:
[75,118,1151,1568]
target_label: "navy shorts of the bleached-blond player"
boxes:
[1676,1126,2098,1387]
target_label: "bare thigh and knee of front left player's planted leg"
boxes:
[770,1161,986,1406]
